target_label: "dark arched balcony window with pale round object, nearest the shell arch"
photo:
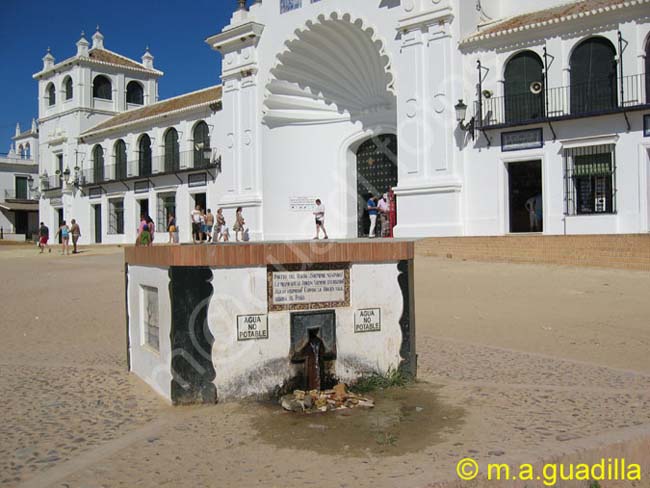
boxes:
[504,51,544,122]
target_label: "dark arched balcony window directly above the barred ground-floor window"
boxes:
[571,37,618,114]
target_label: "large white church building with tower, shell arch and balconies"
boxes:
[13,0,650,243]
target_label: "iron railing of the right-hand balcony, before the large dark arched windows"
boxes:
[475,74,650,128]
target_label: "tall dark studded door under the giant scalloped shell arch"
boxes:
[357,134,397,237]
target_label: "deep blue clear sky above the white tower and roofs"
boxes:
[0,0,237,153]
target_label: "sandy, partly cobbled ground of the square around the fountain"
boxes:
[0,246,650,488]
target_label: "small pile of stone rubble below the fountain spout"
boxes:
[280,383,375,413]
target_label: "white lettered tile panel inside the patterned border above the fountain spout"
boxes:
[272,269,345,305]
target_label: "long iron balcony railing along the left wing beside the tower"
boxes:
[77,150,213,186]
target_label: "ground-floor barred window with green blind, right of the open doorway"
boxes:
[564,144,616,215]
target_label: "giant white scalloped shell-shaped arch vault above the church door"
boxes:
[264,11,395,123]
